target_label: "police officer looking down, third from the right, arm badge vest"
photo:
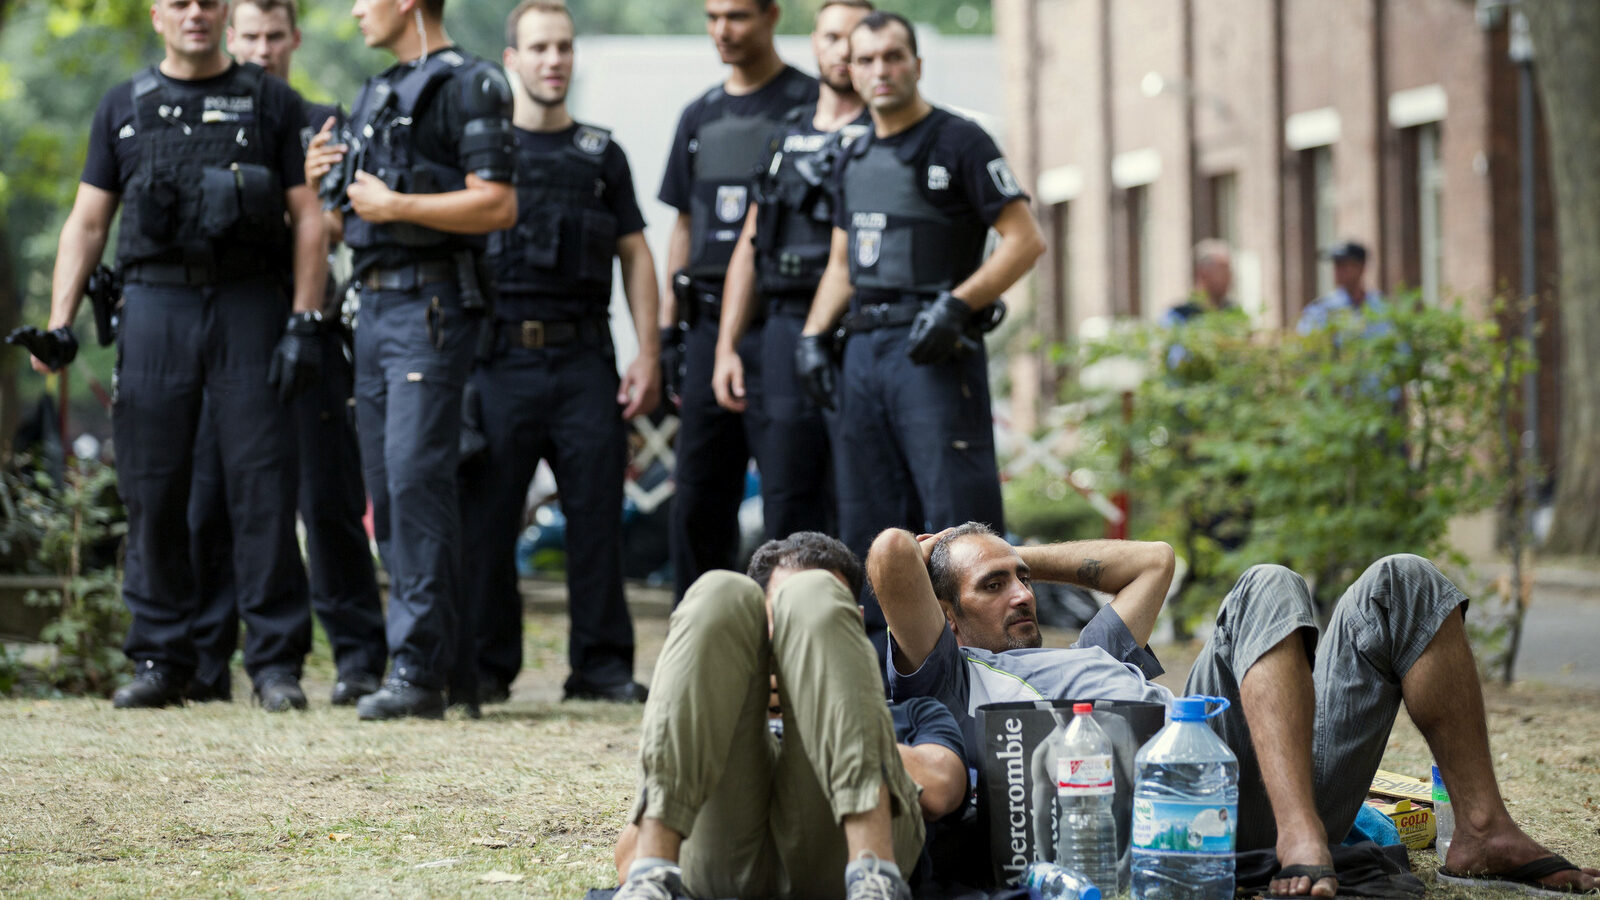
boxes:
[659,0,816,599]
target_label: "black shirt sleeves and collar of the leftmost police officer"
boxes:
[83,62,306,194]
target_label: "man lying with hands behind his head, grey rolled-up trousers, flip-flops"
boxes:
[867,522,1600,897]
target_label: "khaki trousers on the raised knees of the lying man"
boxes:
[632,572,923,900]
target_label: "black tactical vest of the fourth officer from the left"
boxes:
[486,125,618,301]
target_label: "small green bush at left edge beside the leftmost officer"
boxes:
[0,461,128,695]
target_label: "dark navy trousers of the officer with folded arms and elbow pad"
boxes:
[355,280,480,689]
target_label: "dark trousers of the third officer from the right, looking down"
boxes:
[667,301,768,602]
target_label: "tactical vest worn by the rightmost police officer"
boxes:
[843,109,989,296]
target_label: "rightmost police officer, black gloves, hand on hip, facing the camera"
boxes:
[795,13,1045,652]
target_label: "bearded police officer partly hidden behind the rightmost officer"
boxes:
[712,0,872,540]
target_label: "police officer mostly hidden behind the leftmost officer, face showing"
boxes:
[189,0,389,706]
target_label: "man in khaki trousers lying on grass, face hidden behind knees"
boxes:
[616,532,968,900]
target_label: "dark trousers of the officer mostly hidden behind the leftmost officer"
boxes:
[189,328,389,685]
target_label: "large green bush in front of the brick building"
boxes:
[1075,296,1531,623]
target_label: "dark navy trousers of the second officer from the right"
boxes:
[755,296,838,540]
